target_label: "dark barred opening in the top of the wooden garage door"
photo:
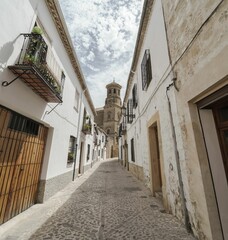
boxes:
[8,113,40,135]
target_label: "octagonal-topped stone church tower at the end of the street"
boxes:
[95,81,122,158]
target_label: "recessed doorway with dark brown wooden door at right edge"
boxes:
[197,87,228,240]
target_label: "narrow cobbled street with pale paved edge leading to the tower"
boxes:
[0,160,194,240]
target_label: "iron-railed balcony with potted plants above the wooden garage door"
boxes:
[6,33,62,103]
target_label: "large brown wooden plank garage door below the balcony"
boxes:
[0,106,47,224]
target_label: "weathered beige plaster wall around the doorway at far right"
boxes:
[162,0,228,239]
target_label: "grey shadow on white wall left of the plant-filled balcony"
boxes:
[0,35,20,72]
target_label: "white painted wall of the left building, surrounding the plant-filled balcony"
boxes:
[0,0,94,179]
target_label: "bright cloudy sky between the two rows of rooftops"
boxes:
[59,0,143,108]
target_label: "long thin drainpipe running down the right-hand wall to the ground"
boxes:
[166,83,192,233]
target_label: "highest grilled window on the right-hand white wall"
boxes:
[141,49,152,91]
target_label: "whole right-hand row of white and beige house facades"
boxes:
[119,0,228,240]
